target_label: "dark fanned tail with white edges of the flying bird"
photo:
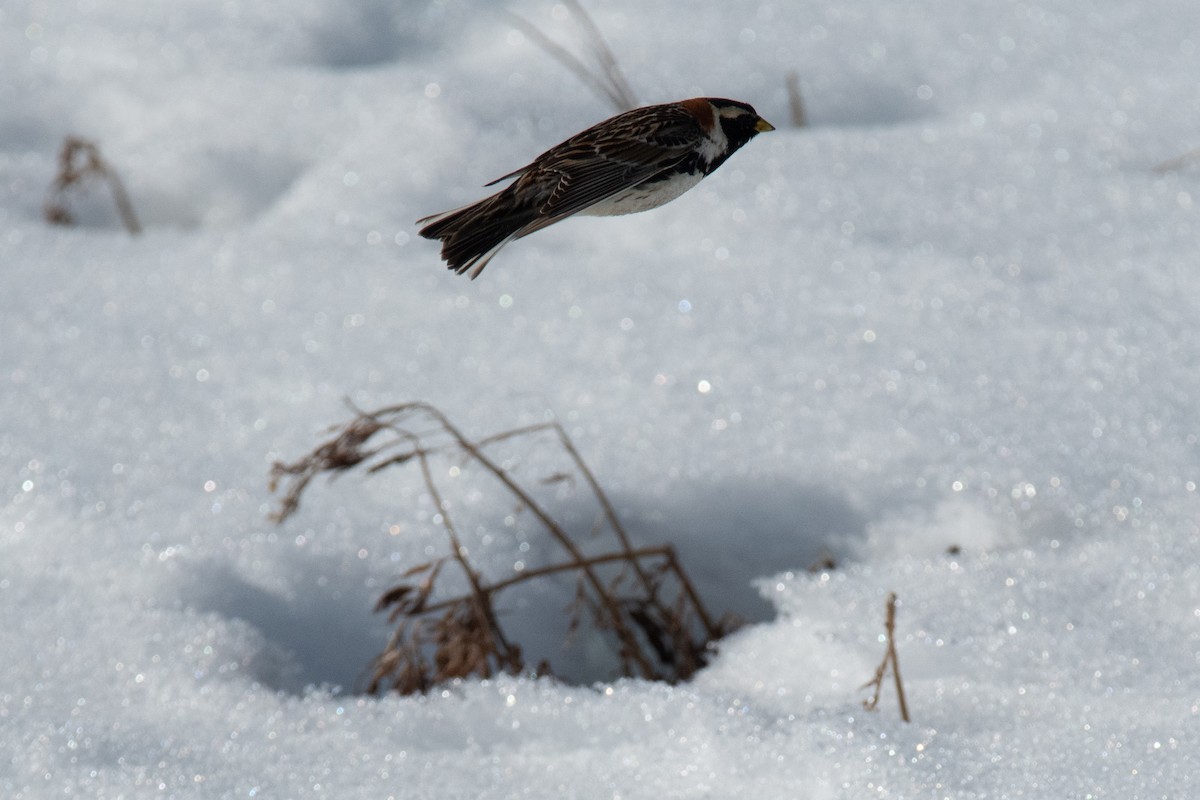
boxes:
[418,191,538,279]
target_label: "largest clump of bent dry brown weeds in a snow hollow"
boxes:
[271,403,734,694]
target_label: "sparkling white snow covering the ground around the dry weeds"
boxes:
[0,0,1200,799]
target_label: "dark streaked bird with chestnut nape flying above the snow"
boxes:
[416,97,775,279]
